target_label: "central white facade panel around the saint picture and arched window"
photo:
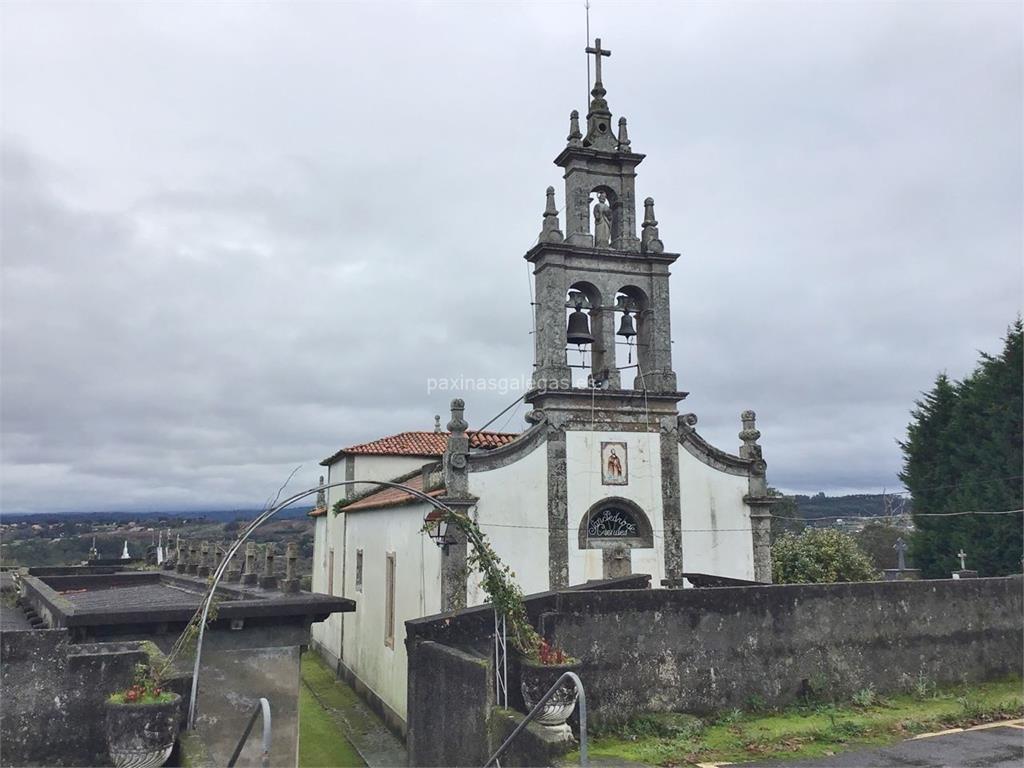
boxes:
[565,432,665,587]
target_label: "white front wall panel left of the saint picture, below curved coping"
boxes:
[466,441,548,605]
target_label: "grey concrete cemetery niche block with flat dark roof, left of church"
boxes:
[7,561,355,766]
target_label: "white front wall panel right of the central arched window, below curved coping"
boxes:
[679,445,754,580]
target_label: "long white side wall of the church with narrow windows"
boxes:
[338,504,441,718]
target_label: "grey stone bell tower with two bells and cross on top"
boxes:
[525,38,685,413]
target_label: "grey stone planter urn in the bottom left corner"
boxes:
[104,693,181,768]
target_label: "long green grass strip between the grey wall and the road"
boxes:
[565,679,1024,766]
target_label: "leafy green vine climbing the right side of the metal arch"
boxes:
[422,509,575,665]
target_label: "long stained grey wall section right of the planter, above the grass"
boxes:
[541,577,1024,727]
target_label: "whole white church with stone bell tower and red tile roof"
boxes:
[312,39,772,730]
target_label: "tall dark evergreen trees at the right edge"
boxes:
[900,318,1024,579]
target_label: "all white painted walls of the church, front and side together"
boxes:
[313,421,754,719]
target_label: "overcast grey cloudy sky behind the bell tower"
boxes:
[0,0,1022,512]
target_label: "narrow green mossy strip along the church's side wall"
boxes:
[299,653,366,768]
